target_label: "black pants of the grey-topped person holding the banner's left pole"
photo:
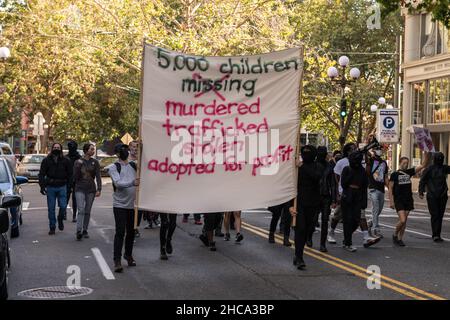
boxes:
[113,208,134,261]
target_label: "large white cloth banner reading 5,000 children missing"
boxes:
[138,45,303,213]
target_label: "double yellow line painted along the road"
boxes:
[242,222,446,300]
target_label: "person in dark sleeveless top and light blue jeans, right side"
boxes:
[366,147,389,238]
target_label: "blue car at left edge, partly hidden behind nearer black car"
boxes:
[0,158,28,238]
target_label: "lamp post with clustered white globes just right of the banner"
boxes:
[327,56,361,147]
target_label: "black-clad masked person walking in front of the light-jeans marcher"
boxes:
[341,151,369,252]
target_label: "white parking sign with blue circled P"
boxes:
[377,109,400,143]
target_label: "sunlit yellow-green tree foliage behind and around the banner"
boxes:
[0,0,401,150]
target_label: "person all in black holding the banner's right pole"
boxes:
[289,145,322,270]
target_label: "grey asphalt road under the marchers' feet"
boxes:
[9,179,450,300]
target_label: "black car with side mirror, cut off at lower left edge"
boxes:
[0,196,22,300]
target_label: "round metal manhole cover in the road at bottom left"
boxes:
[17,286,93,299]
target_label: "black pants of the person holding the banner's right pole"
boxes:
[295,204,319,258]
